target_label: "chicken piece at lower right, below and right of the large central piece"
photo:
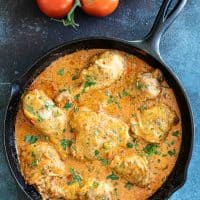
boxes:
[110,150,149,187]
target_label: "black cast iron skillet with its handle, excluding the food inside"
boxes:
[4,0,194,200]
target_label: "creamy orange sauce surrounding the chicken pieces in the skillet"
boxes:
[15,49,181,200]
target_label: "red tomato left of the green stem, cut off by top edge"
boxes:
[36,0,74,18]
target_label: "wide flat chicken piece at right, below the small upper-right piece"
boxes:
[131,104,178,143]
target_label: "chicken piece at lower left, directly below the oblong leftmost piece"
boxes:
[21,142,65,184]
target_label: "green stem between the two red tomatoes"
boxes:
[54,0,81,28]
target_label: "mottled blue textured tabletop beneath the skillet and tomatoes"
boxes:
[0,0,200,200]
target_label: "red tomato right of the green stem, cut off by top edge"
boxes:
[81,0,119,17]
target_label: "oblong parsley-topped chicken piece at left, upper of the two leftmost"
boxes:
[23,89,67,136]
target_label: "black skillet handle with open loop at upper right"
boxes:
[143,0,187,57]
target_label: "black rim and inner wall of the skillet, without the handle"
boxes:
[4,38,193,200]
